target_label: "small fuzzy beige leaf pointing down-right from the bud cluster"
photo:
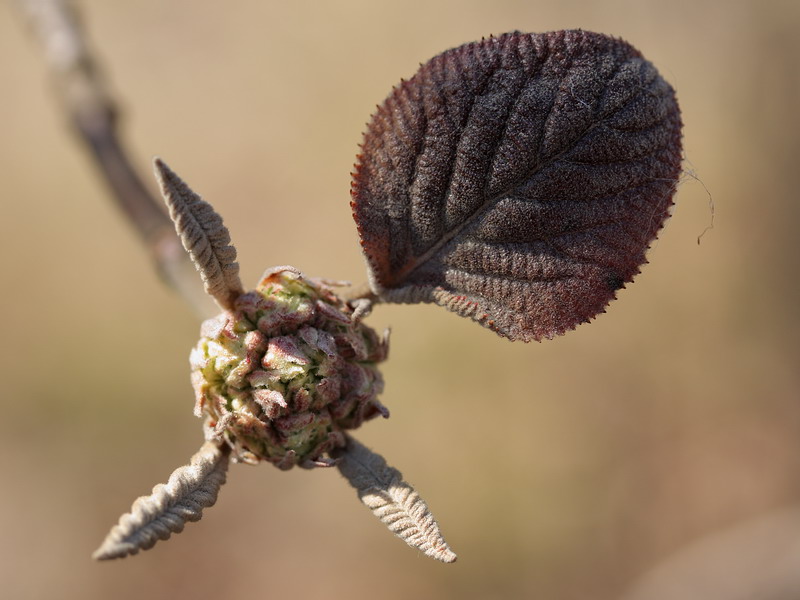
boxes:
[337,436,456,563]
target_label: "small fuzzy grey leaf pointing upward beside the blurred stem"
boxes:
[153,158,244,310]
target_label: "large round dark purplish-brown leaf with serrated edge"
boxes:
[351,31,682,341]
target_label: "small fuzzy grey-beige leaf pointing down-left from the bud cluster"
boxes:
[92,442,230,560]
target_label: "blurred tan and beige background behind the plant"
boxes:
[0,0,800,600]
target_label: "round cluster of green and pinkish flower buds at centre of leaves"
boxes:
[190,267,389,469]
